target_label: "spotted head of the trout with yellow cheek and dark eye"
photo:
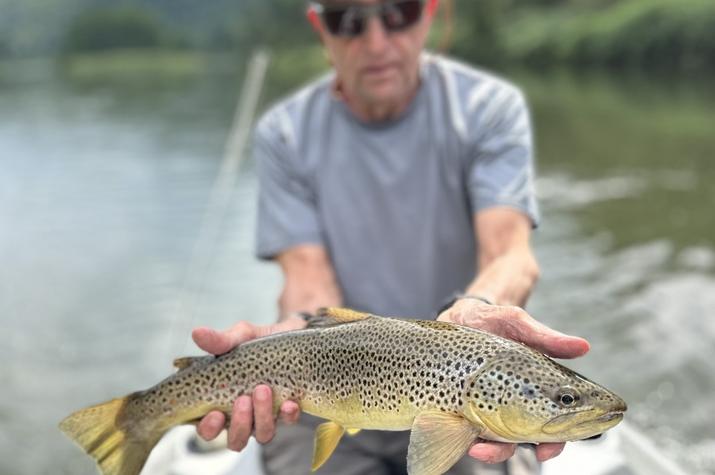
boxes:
[465,351,626,443]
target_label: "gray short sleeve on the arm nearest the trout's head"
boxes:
[468,86,539,227]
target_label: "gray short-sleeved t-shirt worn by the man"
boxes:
[253,54,538,318]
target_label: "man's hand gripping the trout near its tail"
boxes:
[191,317,305,451]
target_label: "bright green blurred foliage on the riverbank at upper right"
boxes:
[502,0,715,71]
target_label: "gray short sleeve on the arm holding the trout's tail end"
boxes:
[253,115,322,259]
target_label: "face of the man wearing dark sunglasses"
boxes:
[321,0,431,113]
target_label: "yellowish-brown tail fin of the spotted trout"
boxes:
[60,395,163,475]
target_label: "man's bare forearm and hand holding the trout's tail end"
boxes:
[192,244,342,451]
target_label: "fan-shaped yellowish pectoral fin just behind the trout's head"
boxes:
[407,411,482,475]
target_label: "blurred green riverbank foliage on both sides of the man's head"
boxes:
[0,0,715,74]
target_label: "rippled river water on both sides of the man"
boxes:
[0,59,715,475]
